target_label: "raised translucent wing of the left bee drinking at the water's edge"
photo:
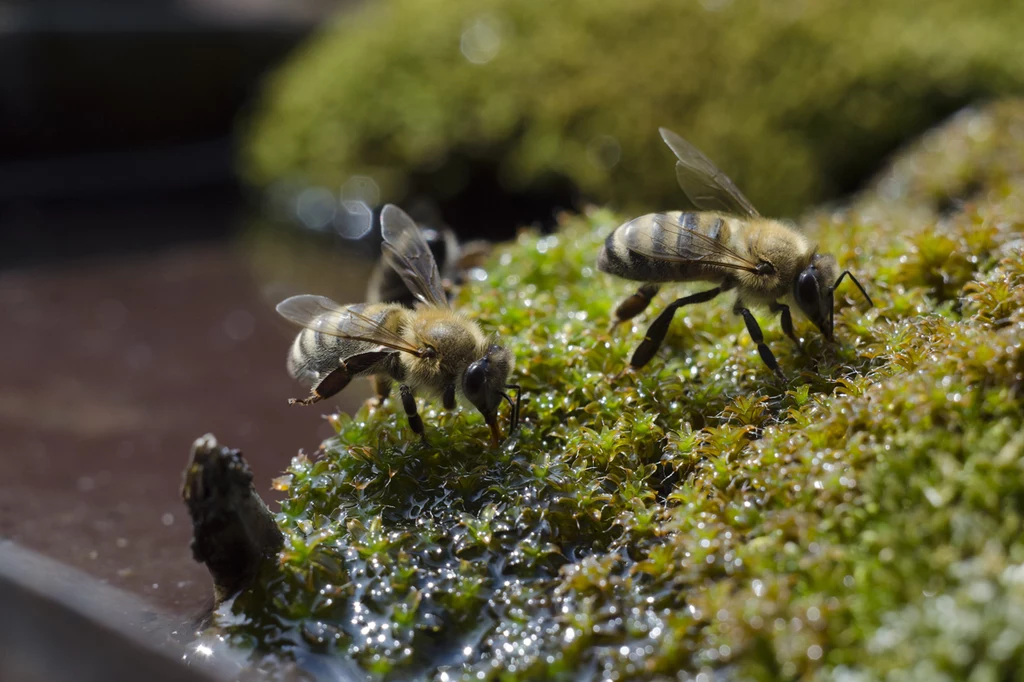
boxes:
[381,204,449,308]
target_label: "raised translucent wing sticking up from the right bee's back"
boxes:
[658,128,761,218]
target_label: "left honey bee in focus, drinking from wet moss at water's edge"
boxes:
[278,204,519,445]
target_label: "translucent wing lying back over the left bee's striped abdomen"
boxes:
[278,294,423,355]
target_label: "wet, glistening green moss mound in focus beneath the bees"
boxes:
[215,102,1024,680]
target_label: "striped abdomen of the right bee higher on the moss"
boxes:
[597,206,732,282]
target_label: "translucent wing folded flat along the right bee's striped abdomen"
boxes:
[626,213,759,273]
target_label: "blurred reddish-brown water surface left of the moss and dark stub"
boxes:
[0,244,365,612]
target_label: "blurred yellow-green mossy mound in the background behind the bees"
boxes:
[243,0,1024,220]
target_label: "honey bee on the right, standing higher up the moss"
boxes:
[597,128,872,381]
